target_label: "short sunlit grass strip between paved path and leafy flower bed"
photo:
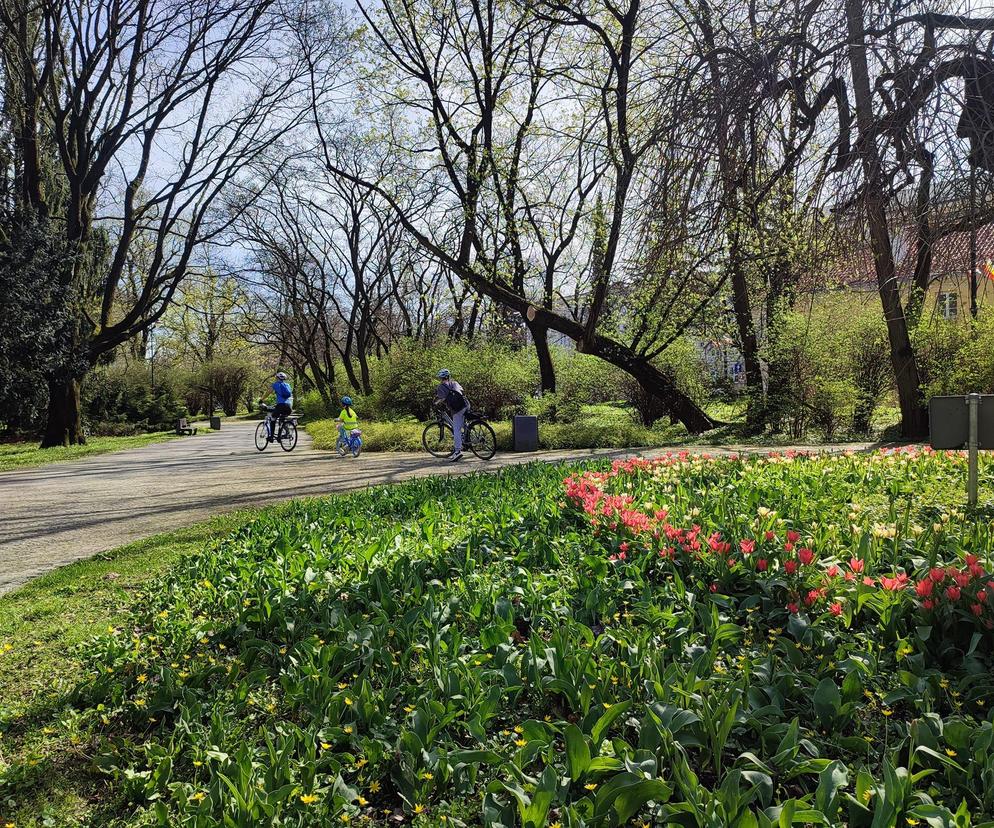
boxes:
[0,512,260,828]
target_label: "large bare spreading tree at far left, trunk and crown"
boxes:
[0,0,340,445]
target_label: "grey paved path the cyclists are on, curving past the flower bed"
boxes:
[0,422,680,594]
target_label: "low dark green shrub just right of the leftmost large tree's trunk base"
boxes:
[83,362,187,435]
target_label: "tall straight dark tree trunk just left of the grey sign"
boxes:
[846,0,928,440]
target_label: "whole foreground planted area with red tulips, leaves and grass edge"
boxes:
[0,450,994,828]
